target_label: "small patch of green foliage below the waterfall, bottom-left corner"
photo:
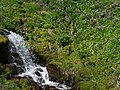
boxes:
[0,65,31,90]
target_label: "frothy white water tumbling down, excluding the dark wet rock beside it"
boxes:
[6,31,70,90]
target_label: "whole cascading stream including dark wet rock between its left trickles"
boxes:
[5,31,71,90]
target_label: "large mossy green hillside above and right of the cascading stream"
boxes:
[0,0,120,90]
